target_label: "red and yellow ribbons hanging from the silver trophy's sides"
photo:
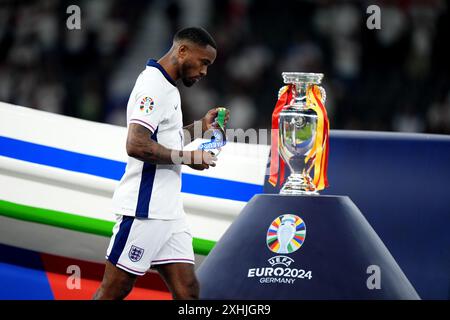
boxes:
[269,85,330,190]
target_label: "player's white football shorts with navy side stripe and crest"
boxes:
[106,215,195,275]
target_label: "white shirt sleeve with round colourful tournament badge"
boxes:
[130,83,167,133]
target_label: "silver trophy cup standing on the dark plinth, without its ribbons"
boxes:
[278,72,325,195]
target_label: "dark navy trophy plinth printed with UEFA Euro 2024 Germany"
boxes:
[197,194,420,301]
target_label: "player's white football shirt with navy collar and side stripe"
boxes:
[113,59,185,220]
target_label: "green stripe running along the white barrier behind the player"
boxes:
[0,200,216,256]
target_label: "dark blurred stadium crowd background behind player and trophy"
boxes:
[0,0,450,134]
